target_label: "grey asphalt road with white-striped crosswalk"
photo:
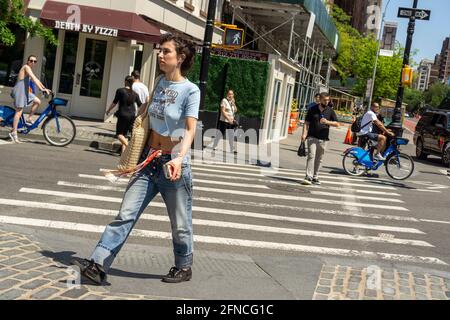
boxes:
[0,129,450,300]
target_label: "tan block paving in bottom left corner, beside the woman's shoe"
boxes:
[0,226,171,300]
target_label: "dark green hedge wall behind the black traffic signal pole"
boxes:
[187,55,269,119]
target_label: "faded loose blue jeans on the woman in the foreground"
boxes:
[90,151,194,272]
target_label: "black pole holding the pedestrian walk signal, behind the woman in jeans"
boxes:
[200,0,217,111]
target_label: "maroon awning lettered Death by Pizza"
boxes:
[41,1,161,43]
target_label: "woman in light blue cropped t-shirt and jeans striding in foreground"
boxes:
[72,34,200,284]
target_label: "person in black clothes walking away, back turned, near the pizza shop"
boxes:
[106,76,142,153]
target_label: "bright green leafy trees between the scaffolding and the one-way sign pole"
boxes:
[331,5,403,100]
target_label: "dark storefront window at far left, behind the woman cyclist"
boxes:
[0,25,26,87]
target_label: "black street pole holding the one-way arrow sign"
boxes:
[389,0,419,136]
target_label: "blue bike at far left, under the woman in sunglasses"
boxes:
[0,93,76,147]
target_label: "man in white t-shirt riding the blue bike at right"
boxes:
[357,102,395,161]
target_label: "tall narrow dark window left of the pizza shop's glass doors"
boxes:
[59,32,79,94]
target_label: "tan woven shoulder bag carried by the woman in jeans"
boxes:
[117,75,162,172]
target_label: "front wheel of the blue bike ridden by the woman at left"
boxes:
[42,115,77,147]
